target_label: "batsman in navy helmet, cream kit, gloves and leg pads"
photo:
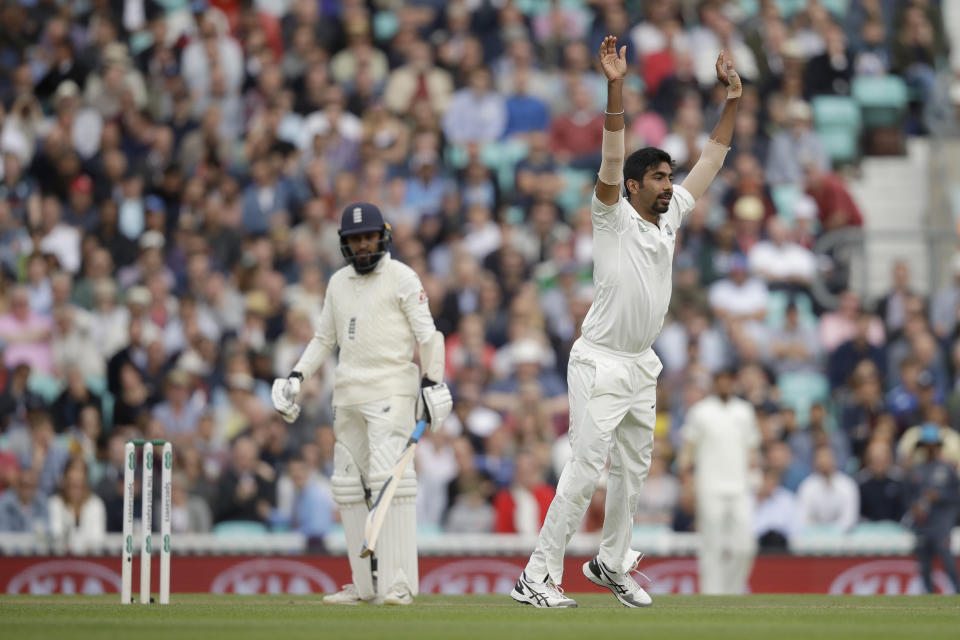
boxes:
[272,202,453,605]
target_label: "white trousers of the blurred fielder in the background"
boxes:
[697,492,757,595]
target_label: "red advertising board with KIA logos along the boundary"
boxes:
[0,555,952,598]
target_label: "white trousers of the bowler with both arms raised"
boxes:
[526,338,663,584]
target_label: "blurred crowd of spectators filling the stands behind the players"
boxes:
[0,0,960,551]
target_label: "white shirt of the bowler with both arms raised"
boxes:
[581,185,695,355]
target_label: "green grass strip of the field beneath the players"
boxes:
[0,593,960,640]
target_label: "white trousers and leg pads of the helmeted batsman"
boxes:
[333,396,419,598]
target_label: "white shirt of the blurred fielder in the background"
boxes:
[681,396,760,496]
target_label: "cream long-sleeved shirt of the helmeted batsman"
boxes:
[314,254,436,407]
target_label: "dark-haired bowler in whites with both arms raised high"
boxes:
[510,36,742,607]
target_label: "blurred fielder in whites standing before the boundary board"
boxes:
[680,370,760,595]
